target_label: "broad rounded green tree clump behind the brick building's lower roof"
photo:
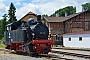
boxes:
[51,6,76,16]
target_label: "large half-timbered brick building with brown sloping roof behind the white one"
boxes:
[43,11,90,45]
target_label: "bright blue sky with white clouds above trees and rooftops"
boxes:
[0,0,90,20]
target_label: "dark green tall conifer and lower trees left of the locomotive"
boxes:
[0,3,17,40]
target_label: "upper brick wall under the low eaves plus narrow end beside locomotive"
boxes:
[43,19,64,34]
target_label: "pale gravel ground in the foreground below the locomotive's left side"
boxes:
[0,51,52,60]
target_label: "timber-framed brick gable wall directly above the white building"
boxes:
[65,12,90,33]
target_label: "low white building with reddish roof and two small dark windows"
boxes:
[63,31,90,48]
